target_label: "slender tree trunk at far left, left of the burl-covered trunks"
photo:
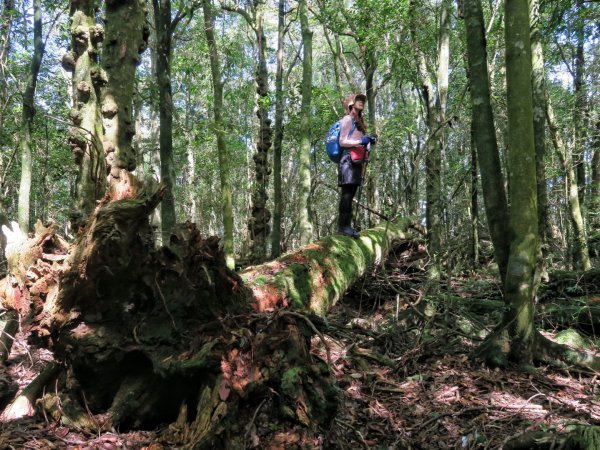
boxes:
[18,0,45,231]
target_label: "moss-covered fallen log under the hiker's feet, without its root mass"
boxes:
[240,221,409,316]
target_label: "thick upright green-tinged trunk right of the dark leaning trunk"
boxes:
[504,0,539,365]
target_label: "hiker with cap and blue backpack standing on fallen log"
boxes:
[338,94,376,239]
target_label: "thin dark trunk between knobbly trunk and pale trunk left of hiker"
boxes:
[271,0,285,258]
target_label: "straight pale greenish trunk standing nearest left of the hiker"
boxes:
[298,0,313,245]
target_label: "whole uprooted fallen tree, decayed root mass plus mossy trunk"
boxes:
[0,187,412,448]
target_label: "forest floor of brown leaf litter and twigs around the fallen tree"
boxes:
[0,247,600,450]
